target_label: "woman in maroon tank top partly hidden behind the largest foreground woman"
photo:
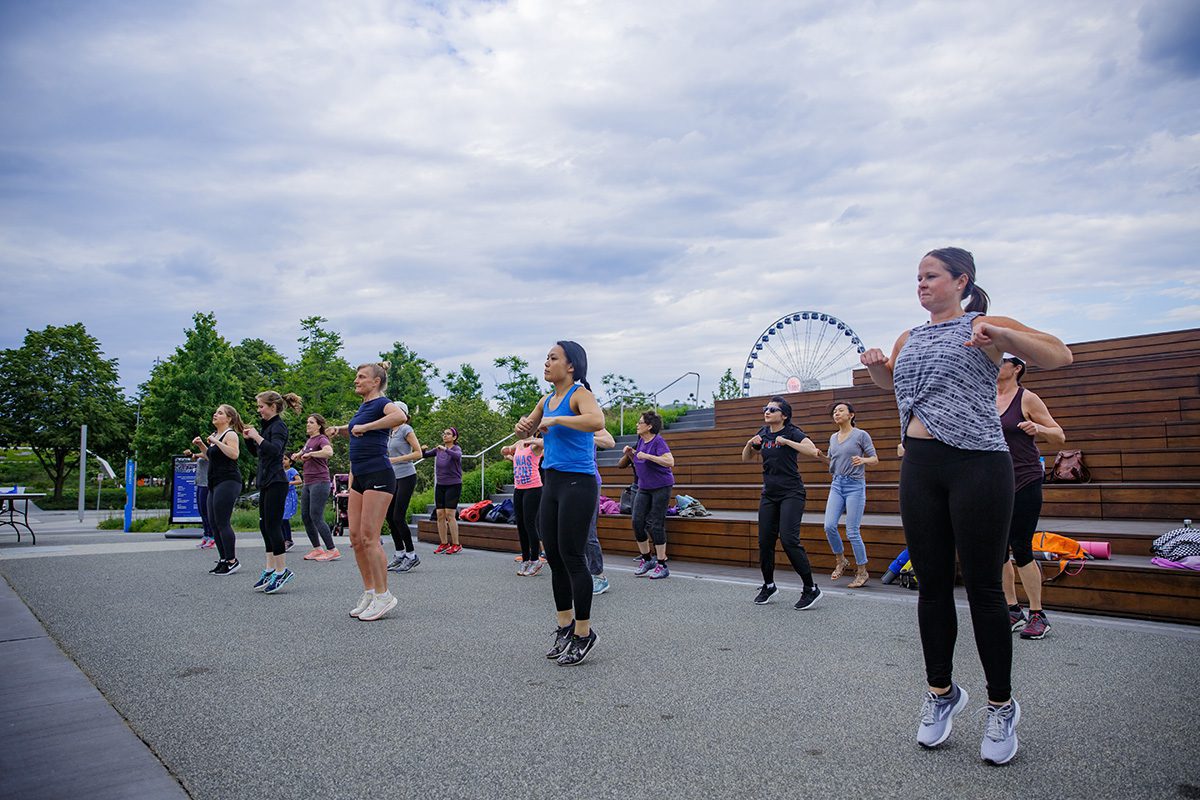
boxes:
[996,355,1067,639]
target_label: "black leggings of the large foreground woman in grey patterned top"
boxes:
[900,438,1013,703]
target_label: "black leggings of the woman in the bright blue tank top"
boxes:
[538,469,600,620]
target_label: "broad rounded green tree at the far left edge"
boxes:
[0,323,133,500]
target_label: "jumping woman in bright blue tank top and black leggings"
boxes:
[516,342,604,666]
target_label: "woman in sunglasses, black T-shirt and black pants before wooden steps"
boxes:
[742,397,822,610]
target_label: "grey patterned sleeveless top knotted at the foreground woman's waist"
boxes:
[892,312,1008,451]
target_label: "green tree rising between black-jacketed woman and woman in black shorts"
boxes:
[286,317,359,422]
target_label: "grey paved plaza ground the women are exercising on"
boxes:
[0,513,1200,800]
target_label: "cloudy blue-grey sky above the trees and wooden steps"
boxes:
[0,0,1200,393]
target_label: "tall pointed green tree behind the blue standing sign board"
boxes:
[133,312,246,477]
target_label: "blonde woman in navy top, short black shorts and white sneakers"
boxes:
[328,361,408,621]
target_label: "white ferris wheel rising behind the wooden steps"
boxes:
[742,311,866,397]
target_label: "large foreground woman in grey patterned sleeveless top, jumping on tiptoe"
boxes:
[862,247,1072,764]
